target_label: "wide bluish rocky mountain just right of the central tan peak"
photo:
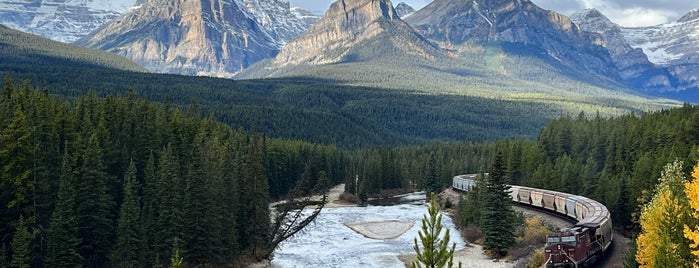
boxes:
[406,0,620,80]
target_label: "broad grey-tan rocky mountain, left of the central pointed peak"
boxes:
[77,0,308,77]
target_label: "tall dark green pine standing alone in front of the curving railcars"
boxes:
[481,153,516,256]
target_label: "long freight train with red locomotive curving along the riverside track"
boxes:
[452,174,613,268]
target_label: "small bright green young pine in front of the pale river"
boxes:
[411,194,461,268]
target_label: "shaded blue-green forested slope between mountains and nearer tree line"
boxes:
[0,57,568,148]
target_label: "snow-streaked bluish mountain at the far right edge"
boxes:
[571,9,699,92]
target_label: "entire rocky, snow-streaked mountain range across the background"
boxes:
[0,0,699,101]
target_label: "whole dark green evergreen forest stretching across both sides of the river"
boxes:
[0,77,699,267]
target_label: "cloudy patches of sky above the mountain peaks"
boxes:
[290,0,699,27]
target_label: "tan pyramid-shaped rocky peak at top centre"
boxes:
[272,0,437,67]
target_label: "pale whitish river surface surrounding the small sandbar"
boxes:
[272,194,464,268]
